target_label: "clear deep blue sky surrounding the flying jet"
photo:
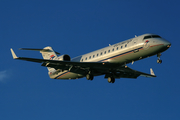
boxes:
[0,0,180,120]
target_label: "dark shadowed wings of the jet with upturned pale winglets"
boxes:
[11,49,156,78]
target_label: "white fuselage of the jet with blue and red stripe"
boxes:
[50,34,171,79]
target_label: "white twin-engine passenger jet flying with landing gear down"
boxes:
[10,34,171,83]
